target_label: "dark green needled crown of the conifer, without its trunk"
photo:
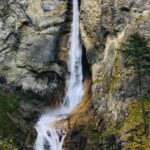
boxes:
[122,33,150,74]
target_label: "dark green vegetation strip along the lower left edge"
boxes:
[0,91,20,150]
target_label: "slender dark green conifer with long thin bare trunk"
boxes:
[123,33,150,133]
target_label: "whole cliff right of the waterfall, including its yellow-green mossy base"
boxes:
[64,0,150,150]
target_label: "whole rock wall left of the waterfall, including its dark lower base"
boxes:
[0,0,71,149]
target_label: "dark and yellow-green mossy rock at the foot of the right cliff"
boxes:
[64,98,150,150]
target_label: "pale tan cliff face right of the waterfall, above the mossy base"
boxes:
[81,0,150,118]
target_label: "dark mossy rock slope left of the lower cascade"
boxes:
[0,90,40,150]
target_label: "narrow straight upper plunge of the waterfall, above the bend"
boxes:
[64,0,83,110]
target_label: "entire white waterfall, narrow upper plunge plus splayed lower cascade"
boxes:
[35,0,83,150]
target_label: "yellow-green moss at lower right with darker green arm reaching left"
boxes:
[89,97,150,150]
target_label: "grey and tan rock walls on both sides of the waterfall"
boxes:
[0,0,150,150]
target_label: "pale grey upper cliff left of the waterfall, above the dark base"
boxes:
[0,0,67,96]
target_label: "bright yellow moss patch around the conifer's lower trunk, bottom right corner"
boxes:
[122,98,150,150]
